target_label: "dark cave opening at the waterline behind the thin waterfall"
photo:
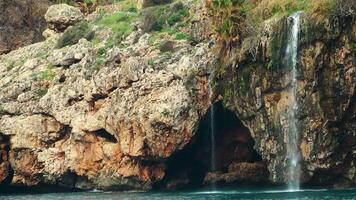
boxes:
[157,102,268,189]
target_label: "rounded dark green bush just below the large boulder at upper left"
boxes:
[56,21,94,48]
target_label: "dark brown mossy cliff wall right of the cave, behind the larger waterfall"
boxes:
[216,11,356,188]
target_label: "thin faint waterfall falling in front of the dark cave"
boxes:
[209,73,216,190]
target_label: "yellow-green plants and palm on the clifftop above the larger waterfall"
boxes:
[206,0,355,50]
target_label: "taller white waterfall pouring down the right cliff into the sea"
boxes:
[286,12,300,190]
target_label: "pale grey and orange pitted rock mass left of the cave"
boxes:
[0,0,217,190]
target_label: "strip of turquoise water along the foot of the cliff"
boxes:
[0,189,356,200]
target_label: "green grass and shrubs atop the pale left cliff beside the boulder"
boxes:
[57,0,192,51]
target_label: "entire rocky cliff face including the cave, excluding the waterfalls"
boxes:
[0,1,356,190]
